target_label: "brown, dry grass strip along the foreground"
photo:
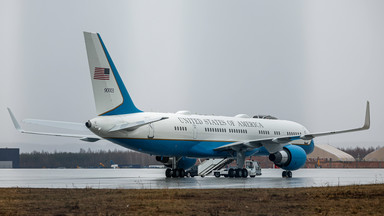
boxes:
[0,185,384,216]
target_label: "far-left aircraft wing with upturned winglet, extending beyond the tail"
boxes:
[8,108,102,142]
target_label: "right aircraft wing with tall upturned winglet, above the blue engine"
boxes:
[214,101,371,153]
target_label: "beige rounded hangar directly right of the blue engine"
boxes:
[308,144,356,161]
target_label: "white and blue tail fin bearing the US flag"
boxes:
[84,32,141,115]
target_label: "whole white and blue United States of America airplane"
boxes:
[8,32,370,178]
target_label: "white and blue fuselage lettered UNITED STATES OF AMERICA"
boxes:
[86,112,309,157]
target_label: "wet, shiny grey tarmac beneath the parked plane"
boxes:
[0,169,384,189]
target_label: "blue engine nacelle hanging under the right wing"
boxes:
[269,145,307,170]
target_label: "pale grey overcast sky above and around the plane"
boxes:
[0,0,384,152]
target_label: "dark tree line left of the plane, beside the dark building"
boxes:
[20,149,161,168]
